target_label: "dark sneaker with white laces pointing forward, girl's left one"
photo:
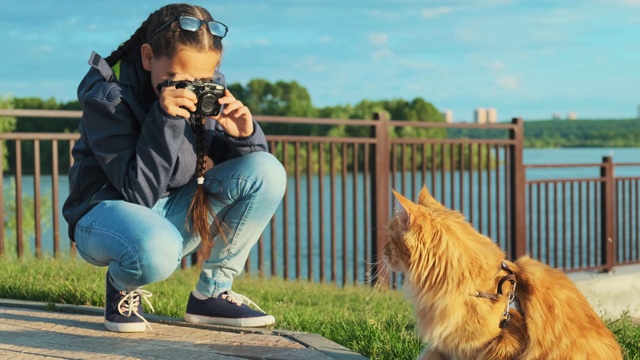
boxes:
[104,272,153,332]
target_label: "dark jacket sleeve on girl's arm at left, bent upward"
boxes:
[82,82,186,207]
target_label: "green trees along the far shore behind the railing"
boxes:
[0,79,640,173]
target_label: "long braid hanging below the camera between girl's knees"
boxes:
[189,114,227,246]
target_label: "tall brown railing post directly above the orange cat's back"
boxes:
[507,118,527,260]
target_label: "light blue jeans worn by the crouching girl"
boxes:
[74,152,287,296]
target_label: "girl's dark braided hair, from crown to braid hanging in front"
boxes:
[106,4,226,246]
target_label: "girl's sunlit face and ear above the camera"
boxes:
[141,44,221,96]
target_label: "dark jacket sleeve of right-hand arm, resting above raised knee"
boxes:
[208,120,269,164]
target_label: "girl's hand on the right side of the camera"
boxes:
[213,89,253,137]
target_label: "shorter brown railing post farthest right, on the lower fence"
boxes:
[600,156,616,271]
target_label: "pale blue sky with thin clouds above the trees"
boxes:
[0,0,640,121]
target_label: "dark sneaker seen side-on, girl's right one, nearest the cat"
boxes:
[184,290,276,327]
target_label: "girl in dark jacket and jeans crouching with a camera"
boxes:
[63,4,286,332]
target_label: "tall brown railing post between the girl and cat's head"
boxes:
[369,113,391,284]
